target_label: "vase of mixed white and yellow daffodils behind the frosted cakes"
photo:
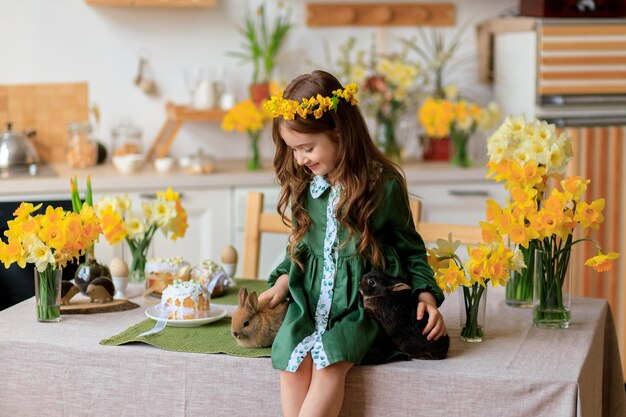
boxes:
[96,187,188,282]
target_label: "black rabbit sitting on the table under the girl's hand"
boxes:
[359,271,450,359]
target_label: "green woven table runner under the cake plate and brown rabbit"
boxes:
[100,280,271,358]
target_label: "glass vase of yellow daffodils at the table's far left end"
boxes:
[0,203,101,322]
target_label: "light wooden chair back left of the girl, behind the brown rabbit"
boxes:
[243,191,291,279]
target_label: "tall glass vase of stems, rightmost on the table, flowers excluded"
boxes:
[533,249,572,329]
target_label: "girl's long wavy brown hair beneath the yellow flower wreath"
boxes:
[272,71,406,267]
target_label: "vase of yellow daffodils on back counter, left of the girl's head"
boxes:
[222,99,271,171]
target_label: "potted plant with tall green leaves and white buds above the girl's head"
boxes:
[231,5,293,103]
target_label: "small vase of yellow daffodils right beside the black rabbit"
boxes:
[428,234,524,342]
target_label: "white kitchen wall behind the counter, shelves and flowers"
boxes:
[0,0,518,163]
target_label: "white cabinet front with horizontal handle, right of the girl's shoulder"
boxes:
[409,181,507,225]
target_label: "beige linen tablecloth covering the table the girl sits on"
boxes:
[0,288,626,417]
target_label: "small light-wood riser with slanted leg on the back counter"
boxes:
[147,102,226,160]
